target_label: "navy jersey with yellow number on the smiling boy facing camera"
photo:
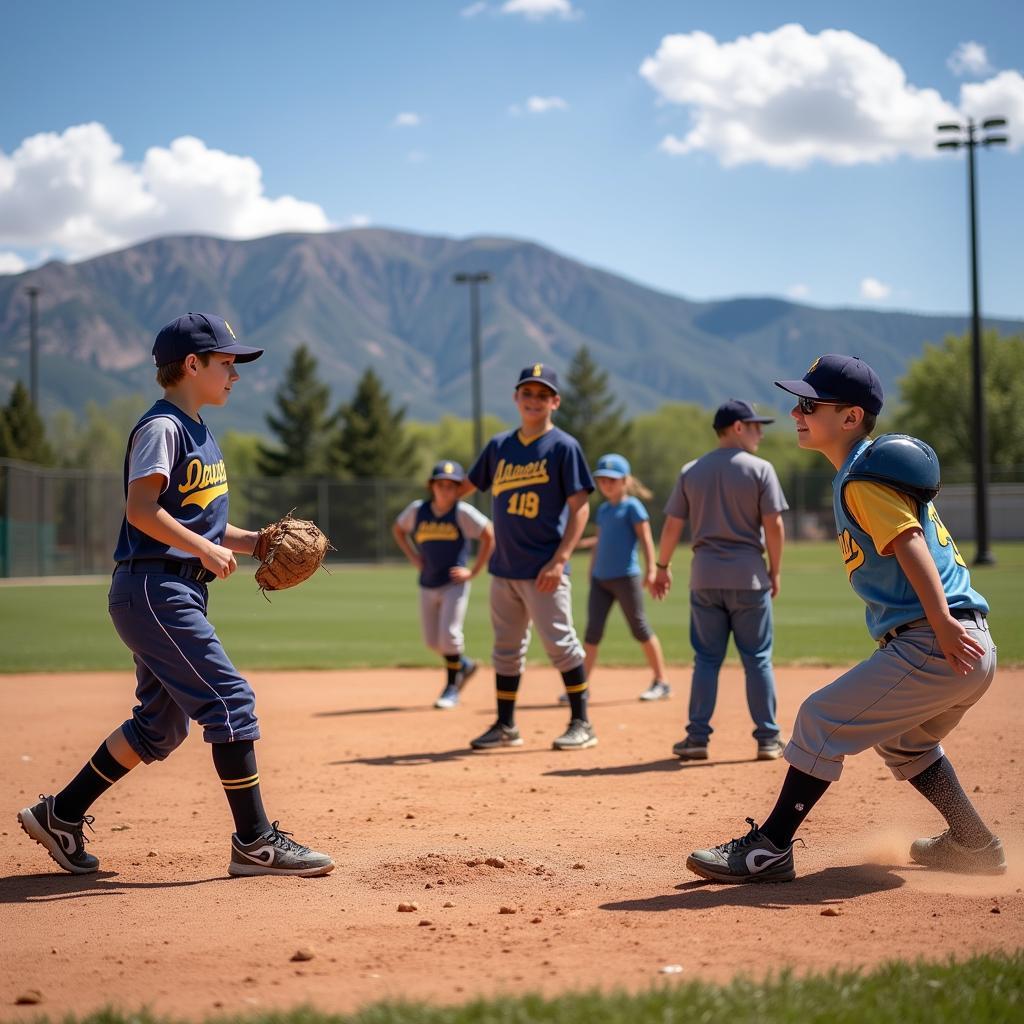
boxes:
[469,427,594,580]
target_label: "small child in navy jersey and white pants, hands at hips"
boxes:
[391,459,495,708]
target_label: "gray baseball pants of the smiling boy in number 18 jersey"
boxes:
[490,577,584,676]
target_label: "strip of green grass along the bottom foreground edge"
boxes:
[22,950,1024,1024]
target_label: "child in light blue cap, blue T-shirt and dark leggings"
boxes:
[583,454,672,700]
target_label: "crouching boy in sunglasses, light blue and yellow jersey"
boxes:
[686,354,1007,882]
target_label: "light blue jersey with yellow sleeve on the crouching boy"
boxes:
[833,438,988,640]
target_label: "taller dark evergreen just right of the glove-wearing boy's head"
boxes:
[257,345,334,477]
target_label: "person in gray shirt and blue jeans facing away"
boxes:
[651,398,788,761]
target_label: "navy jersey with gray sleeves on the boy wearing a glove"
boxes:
[114,398,227,565]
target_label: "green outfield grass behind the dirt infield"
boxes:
[0,543,1024,673]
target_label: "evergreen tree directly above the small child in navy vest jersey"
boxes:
[331,369,417,480]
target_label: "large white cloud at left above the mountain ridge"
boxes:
[0,122,332,258]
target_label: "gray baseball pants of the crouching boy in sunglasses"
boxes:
[784,615,995,782]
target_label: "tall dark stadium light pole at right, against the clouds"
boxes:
[936,118,1007,565]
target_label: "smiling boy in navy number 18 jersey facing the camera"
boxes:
[460,362,597,751]
